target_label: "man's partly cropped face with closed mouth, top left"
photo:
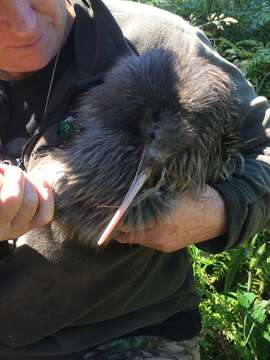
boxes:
[0,0,72,78]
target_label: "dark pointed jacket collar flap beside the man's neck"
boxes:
[45,0,135,117]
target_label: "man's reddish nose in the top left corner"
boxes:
[0,0,37,36]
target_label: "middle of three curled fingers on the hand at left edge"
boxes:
[11,177,39,235]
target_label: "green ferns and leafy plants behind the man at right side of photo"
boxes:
[135,0,270,360]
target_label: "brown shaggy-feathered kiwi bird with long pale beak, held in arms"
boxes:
[31,49,239,246]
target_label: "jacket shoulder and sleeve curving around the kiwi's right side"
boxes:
[106,0,270,253]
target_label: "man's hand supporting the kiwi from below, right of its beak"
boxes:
[115,186,226,253]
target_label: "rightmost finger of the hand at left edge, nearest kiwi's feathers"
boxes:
[30,180,54,229]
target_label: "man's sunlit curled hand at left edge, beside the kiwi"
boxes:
[0,163,54,241]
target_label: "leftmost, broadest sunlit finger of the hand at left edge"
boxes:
[0,164,25,222]
